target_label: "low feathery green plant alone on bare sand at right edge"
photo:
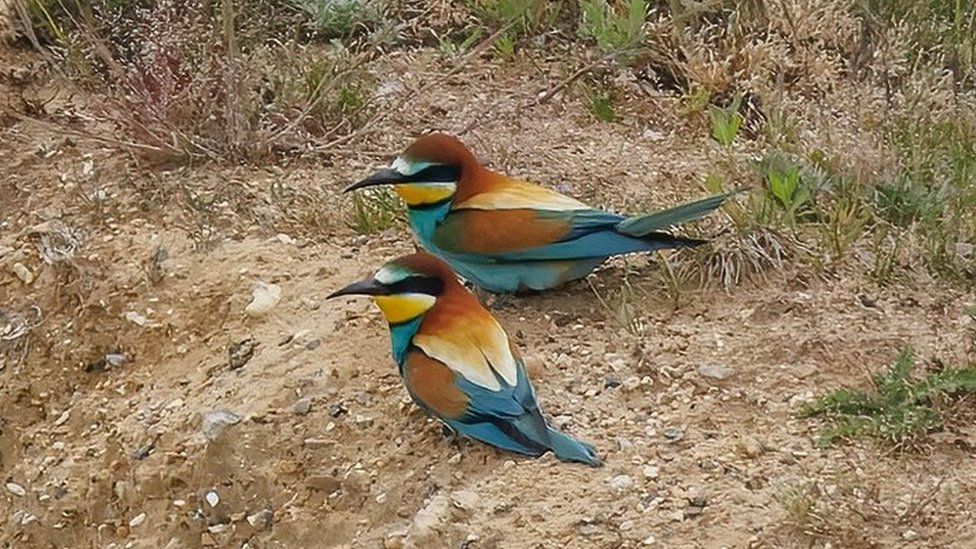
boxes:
[800,349,976,446]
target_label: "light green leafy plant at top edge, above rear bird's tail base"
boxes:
[579,0,648,60]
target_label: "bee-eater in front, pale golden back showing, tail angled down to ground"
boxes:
[329,252,602,467]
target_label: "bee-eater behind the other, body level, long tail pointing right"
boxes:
[345,133,731,293]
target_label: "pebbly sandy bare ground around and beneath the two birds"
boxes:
[0,39,976,548]
